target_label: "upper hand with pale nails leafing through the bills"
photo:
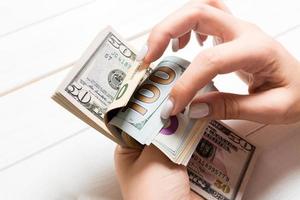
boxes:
[139,0,300,123]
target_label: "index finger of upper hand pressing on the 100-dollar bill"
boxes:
[162,42,247,115]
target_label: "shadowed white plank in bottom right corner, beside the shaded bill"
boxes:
[243,128,300,200]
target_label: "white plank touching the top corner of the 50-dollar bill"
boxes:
[0,0,181,96]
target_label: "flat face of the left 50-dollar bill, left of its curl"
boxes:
[65,27,136,119]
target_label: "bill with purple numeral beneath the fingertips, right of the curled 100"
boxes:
[152,82,217,165]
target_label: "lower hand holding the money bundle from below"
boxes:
[115,145,203,200]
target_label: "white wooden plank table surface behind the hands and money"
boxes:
[0,0,300,200]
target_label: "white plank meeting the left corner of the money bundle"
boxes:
[0,34,146,170]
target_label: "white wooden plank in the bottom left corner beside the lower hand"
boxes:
[0,129,121,200]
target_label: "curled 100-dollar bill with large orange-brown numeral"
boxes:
[109,57,189,145]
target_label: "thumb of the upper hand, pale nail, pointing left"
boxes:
[189,88,292,123]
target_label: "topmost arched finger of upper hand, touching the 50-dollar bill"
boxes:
[144,4,240,63]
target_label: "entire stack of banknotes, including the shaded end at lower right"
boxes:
[52,27,256,199]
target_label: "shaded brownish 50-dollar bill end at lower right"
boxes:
[188,121,256,200]
